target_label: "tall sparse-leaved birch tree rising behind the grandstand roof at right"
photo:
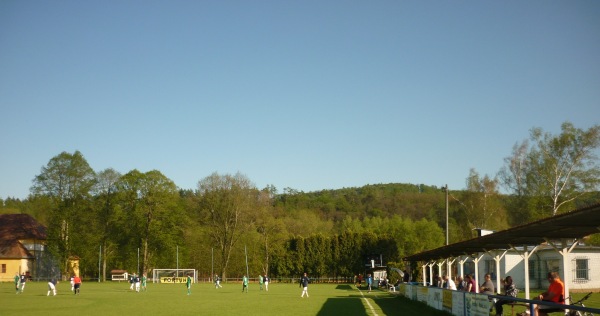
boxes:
[499,122,600,218]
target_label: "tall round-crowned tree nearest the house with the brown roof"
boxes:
[30,151,95,275]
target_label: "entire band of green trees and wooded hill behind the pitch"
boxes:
[0,122,600,279]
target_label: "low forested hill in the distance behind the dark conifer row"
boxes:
[273,183,600,241]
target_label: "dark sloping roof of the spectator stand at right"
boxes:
[404,204,600,261]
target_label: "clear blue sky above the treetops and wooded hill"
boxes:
[0,0,600,198]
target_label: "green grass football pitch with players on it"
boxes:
[0,282,448,316]
